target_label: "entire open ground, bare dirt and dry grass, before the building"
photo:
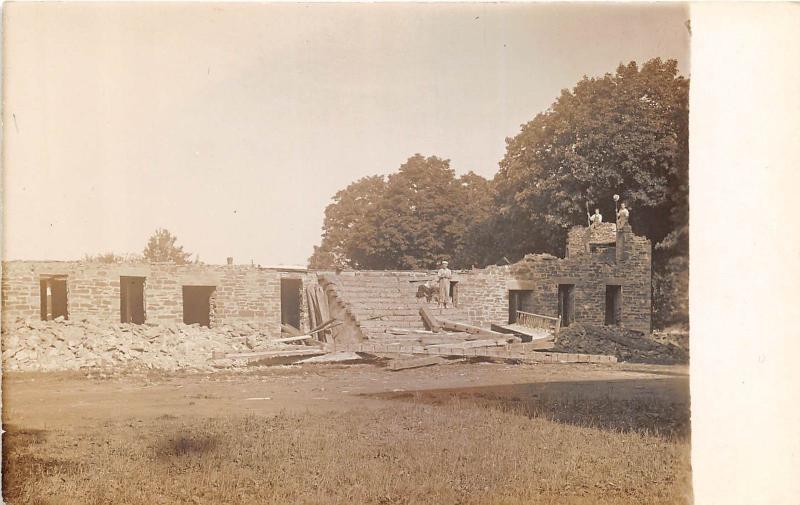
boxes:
[3,363,690,503]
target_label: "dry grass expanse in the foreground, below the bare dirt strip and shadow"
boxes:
[3,401,690,505]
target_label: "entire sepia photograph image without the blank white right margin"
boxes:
[2,2,700,505]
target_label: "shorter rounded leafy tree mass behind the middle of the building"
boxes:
[309,154,491,269]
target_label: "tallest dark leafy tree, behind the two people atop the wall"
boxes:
[494,59,689,256]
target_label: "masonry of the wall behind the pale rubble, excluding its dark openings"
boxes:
[2,261,316,333]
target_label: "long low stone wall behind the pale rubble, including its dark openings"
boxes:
[2,261,316,335]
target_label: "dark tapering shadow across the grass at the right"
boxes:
[374,377,691,439]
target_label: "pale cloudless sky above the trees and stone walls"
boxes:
[3,3,689,265]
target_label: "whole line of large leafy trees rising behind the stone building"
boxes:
[309,58,689,325]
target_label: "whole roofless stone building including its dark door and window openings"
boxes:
[2,223,652,340]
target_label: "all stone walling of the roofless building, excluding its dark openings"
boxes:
[2,224,652,333]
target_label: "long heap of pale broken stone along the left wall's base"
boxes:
[2,318,297,371]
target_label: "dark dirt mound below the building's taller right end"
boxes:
[553,323,689,365]
